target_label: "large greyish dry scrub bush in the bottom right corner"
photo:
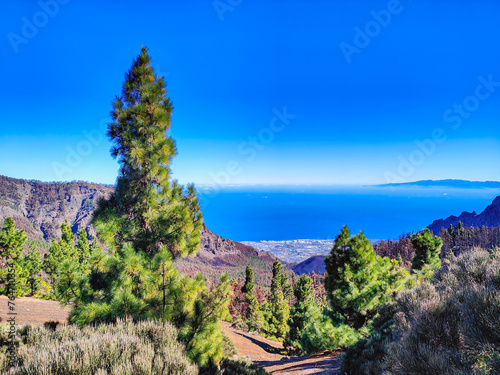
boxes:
[384,249,500,374]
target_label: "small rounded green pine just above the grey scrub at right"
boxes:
[411,228,443,272]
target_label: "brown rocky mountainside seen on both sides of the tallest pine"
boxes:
[0,176,276,285]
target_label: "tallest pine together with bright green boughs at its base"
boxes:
[66,47,229,368]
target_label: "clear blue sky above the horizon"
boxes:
[0,0,500,184]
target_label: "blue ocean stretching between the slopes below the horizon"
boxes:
[198,185,500,241]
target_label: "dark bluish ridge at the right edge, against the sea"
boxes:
[428,196,500,234]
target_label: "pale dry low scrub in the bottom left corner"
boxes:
[0,320,198,375]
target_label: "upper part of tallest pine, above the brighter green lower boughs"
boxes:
[94,47,203,259]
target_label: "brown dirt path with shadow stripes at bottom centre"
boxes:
[221,322,341,375]
